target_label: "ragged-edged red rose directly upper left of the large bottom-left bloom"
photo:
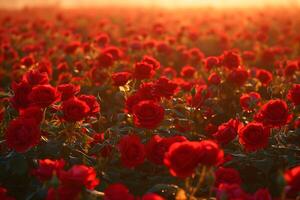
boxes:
[32,159,65,181]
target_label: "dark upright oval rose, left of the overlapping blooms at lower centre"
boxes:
[118,135,145,168]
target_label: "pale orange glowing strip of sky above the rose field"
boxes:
[0,0,300,9]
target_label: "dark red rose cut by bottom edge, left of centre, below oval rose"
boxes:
[104,183,134,200]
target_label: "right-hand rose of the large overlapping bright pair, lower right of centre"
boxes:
[197,140,224,166]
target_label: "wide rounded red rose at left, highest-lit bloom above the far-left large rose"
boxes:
[28,85,60,108]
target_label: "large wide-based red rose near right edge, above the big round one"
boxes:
[255,99,292,127]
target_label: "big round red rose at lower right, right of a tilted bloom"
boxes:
[238,122,270,152]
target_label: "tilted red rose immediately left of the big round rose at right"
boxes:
[213,119,241,145]
